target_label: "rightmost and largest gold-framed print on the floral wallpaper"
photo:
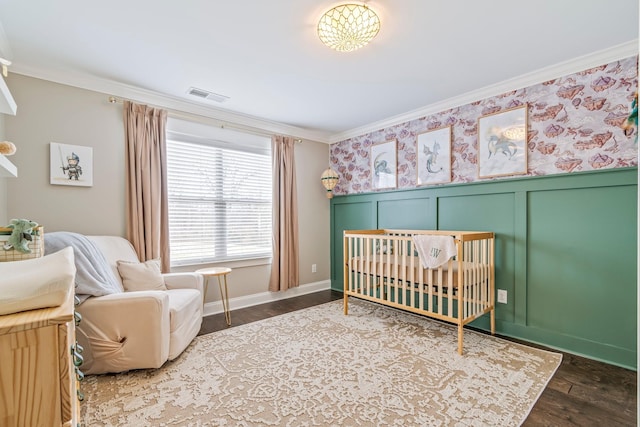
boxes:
[478,104,529,178]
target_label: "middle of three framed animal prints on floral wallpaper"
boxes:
[416,126,451,185]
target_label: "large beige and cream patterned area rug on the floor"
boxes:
[82,299,562,426]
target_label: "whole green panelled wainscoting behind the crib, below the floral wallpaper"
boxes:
[331,168,638,369]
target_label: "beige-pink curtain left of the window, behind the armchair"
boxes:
[124,101,171,273]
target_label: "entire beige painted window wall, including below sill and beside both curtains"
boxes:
[6,73,330,301]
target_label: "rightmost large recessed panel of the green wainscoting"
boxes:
[527,185,638,362]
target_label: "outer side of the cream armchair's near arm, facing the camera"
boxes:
[77,291,169,374]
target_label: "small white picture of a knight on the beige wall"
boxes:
[49,142,93,187]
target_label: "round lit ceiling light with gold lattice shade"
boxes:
[318,3,380,52]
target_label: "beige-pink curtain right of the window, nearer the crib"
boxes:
[269,135,300,292]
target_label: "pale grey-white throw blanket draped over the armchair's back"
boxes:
[44,231,122,302]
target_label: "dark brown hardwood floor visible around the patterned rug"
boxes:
[200,291,638,427]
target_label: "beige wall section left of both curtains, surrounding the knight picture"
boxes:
[5,73,125,235]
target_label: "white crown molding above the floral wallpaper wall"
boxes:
[329,39,638,144]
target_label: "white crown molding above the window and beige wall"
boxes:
[11,64,330,144]
